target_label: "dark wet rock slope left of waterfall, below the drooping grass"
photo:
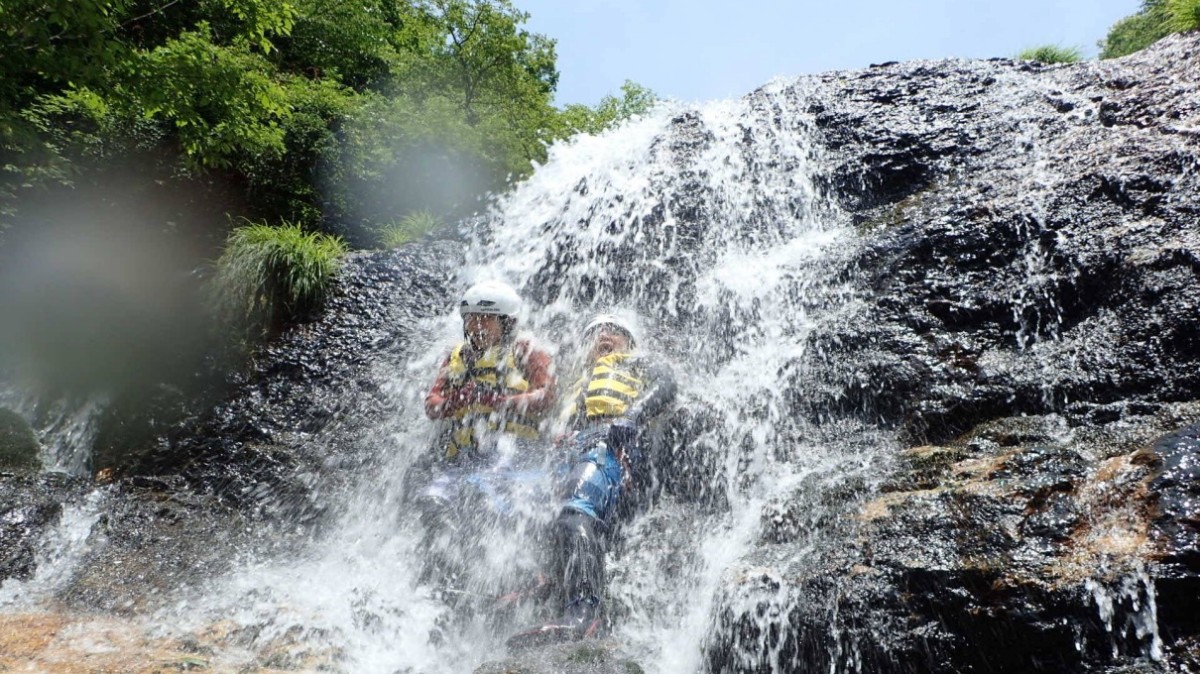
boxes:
[121,242,461,513]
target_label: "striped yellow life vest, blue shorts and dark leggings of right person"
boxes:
[553,354,676,621]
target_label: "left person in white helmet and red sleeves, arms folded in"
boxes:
[425,281,556,461]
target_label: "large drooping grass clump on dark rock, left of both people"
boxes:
[211,223,346,332]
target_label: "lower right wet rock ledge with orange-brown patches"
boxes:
[709,403,1200,673]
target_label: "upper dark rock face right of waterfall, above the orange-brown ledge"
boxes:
[792,35,1200,443]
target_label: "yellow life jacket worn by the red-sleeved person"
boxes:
[446,342,540,459]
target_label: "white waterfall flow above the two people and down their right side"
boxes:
[470,84,892,672]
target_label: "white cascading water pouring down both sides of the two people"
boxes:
[169,77,887,673]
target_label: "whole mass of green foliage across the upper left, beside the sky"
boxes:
[0,0,576,239]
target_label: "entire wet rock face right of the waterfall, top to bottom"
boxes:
[707,35,1200,673]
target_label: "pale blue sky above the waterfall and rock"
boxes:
[523,0,1140,104]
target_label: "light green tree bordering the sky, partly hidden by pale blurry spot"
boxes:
[324,0,558,238]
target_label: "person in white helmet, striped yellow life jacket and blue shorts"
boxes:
[509,314,677,648]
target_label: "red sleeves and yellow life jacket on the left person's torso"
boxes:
[425,339,554,459]
